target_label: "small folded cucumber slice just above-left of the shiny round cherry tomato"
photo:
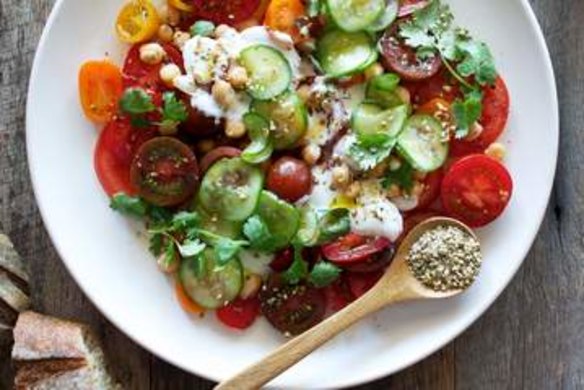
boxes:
[241,112,274,164]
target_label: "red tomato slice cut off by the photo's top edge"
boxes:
[194,0,261,26]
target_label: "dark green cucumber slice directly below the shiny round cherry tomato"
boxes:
[256,191,300,251]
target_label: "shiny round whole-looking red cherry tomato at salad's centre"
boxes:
[266,157,312,202]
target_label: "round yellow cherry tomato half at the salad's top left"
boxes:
[116,0,161,43]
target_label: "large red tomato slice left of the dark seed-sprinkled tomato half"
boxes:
[94,118,155,196]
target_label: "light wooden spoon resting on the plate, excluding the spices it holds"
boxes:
[215,217,476,390]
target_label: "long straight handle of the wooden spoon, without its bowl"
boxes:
[215,288,388,390]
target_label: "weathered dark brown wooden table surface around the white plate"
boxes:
[0,0,584,390]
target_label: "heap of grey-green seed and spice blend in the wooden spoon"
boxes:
[406,226,482,291]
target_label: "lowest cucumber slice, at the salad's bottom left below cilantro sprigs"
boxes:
[179,248,243,309]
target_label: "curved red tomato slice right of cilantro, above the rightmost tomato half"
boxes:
[450,77,510,157]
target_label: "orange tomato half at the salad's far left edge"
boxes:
[79,60,123,123]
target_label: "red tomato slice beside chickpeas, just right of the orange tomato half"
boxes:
[122,43,184,91]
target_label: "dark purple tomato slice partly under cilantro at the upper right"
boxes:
[379,25,442,81]
